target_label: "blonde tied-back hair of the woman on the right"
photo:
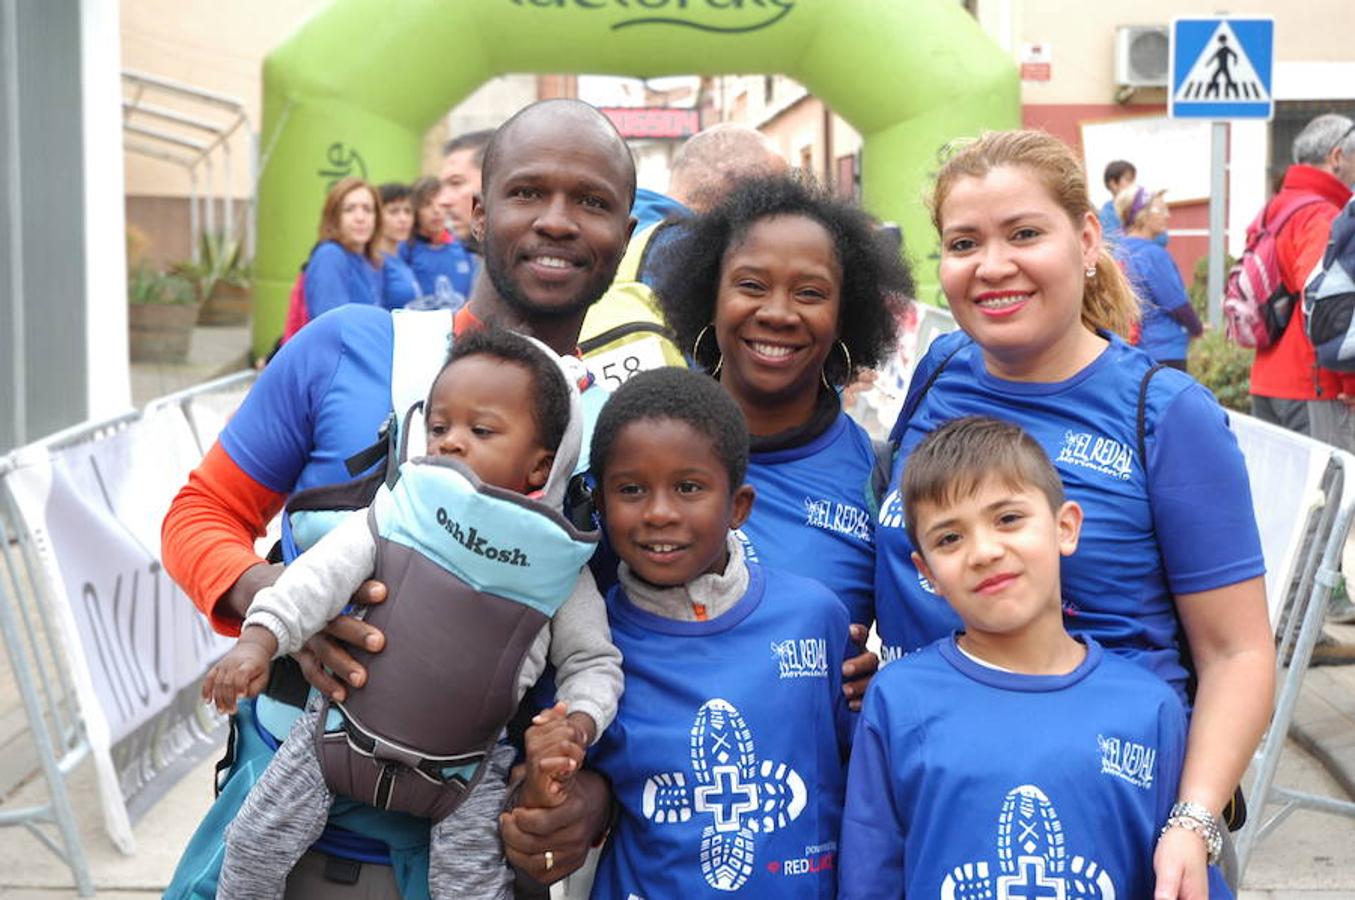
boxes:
[931,131,1140,341]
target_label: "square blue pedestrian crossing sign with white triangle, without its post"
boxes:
[1167,18,1275,119]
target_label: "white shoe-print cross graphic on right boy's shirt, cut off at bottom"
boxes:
[940,785,1115,900]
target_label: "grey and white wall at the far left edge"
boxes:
[0,0,130,453]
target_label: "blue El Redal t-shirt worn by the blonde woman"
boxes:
[875,332,1266,697]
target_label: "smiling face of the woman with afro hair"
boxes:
[714,216,843,434]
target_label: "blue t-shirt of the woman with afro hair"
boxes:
[740,412,875,628]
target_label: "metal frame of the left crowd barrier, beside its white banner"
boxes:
[0,371,256,897]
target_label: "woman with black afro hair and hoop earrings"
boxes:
[656,175,913,706]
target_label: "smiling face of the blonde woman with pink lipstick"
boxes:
[938,165,1104,381]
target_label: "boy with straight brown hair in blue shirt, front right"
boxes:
[839,416,1230,900]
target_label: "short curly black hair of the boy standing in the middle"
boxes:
[589,369,748,492]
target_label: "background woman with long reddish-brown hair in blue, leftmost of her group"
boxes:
[305,176,381,315]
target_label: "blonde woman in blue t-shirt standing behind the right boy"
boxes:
[875,131,1275,894]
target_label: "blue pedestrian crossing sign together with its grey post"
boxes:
[1167,16,1275,328]
